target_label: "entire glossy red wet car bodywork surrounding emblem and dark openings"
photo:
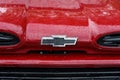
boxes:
[0,0,120,67]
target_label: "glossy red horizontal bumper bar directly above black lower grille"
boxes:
[0,53,120,68]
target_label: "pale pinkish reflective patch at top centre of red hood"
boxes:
[29,0,80,9]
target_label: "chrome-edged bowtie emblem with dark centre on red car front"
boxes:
[41,35,77,47]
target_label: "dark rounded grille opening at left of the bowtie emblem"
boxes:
[0,32,20,46]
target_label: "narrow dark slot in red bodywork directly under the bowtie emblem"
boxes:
[28,50,86,54]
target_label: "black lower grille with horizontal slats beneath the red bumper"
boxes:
[0,68,120,80]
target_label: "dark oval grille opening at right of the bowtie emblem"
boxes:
[97,33,120,48]
